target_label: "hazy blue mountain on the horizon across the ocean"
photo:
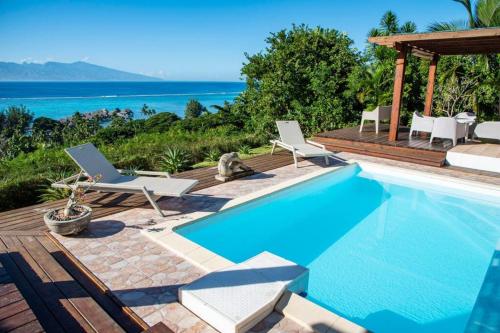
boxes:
[0,61,161,81]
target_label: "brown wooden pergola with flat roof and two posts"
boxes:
[368,28,500,141]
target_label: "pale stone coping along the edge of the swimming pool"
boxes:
[141,160,500,333]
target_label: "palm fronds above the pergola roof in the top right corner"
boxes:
[428,0,500,31]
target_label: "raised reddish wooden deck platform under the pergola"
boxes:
[314,125,453,167]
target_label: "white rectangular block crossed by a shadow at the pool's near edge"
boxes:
[179,252,309,333]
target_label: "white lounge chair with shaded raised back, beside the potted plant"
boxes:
[52,143,198,216]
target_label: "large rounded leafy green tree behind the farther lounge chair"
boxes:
[233,25,360,136]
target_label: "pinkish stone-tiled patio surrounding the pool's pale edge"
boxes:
[51,153,500,332]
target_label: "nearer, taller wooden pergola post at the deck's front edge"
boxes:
[389,44,407,141]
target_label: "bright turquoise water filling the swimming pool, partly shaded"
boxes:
[176,166,500,333]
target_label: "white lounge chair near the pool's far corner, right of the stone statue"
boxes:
[271,120,334,168]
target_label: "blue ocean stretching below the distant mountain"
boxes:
[0,81,245,119]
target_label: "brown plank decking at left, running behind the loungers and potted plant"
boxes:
[0,151,293,333]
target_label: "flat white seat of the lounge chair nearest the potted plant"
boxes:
[110,176,198,197]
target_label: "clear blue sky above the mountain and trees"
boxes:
[0,0,465,81]
